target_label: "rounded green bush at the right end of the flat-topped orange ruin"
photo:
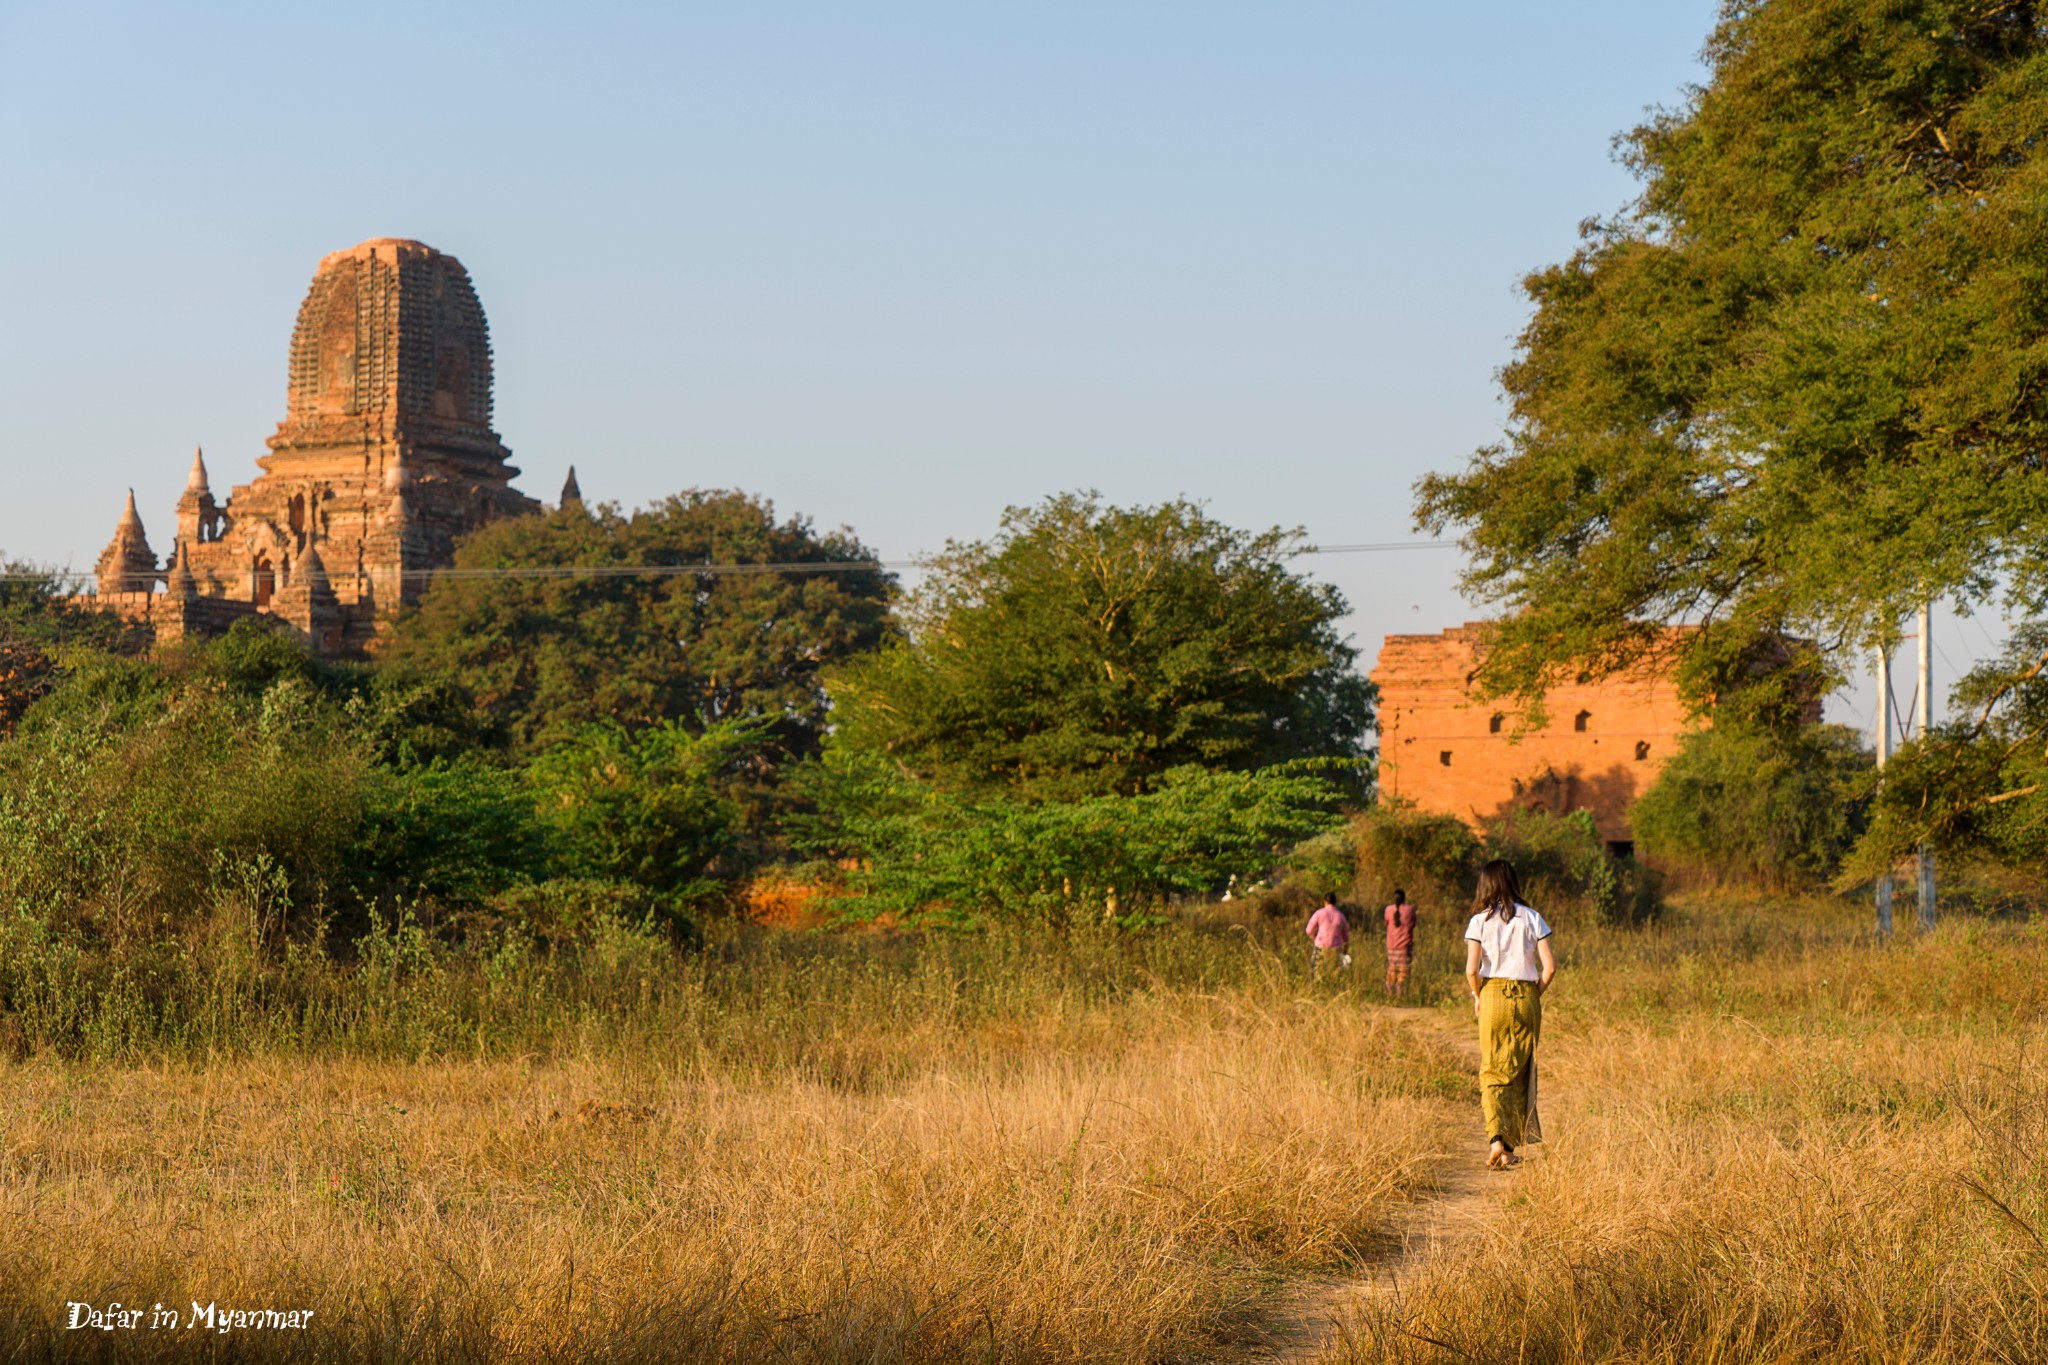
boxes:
[1632,718,1872,888]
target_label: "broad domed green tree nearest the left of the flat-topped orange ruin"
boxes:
[831,493,1372,800]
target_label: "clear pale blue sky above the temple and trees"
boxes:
[19,0,1980,718]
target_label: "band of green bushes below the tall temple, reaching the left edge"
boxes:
[0,620,762,941]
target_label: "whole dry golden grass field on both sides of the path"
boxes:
[0,900,2048,1365]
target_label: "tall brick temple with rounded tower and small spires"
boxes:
[94,237,541,655]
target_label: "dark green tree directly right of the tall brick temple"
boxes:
[387,491,893,761]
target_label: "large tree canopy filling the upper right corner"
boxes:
[1417,0,2048,716]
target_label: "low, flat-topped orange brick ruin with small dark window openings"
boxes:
[1372,624,1694,847]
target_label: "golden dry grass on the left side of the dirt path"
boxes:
[0,941,1468,1363]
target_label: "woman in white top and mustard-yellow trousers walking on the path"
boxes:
[1464,857,1556,1171]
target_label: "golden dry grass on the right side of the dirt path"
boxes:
[1329,902,2048,1365]
